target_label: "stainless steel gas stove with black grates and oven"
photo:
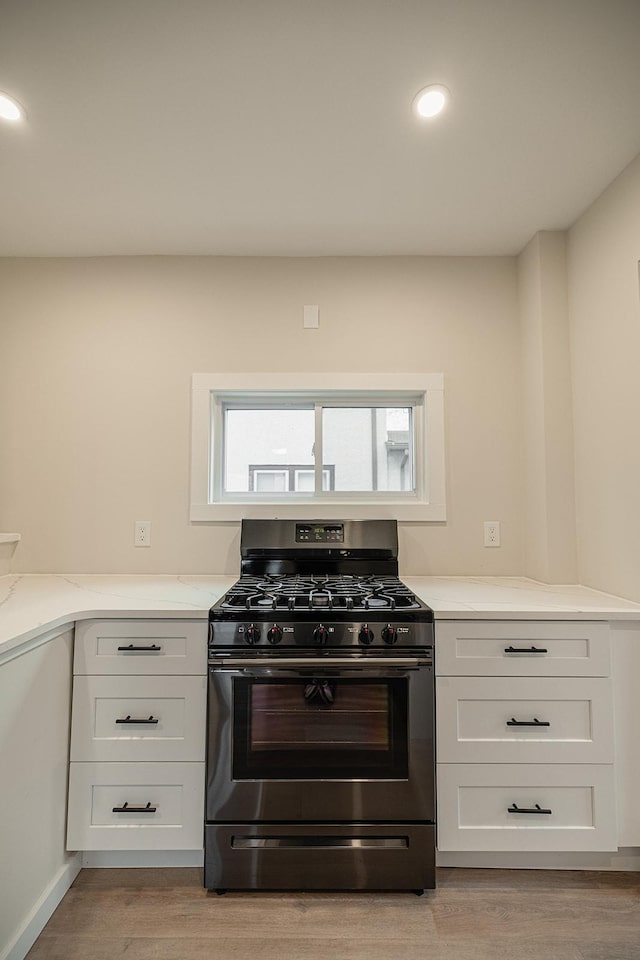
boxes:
[205,520,435,891]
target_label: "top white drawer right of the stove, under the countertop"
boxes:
[435,620,610,677]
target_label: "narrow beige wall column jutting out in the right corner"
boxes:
[518,231,577,583]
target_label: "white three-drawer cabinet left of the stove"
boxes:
[67,620,207,850]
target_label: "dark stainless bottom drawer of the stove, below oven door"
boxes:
[204,823,435,896]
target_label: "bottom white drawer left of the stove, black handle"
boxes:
[67,763,204,850]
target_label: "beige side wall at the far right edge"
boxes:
[568,157,640,600]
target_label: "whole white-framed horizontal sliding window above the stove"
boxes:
[191,374,446,521]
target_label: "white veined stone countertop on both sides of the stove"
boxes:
[0,574,640,654]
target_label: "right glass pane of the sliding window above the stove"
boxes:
[322,407,414,491]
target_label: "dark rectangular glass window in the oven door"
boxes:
[233,677,408,780]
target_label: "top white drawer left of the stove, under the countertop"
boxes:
[73,620,207,675]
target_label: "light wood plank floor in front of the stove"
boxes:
[28,868,640,960]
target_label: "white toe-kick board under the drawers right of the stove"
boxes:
[436,847,640,871]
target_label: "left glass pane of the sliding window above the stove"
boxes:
[224,408,315,493]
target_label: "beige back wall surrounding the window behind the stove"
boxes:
[0,257,522,575]
